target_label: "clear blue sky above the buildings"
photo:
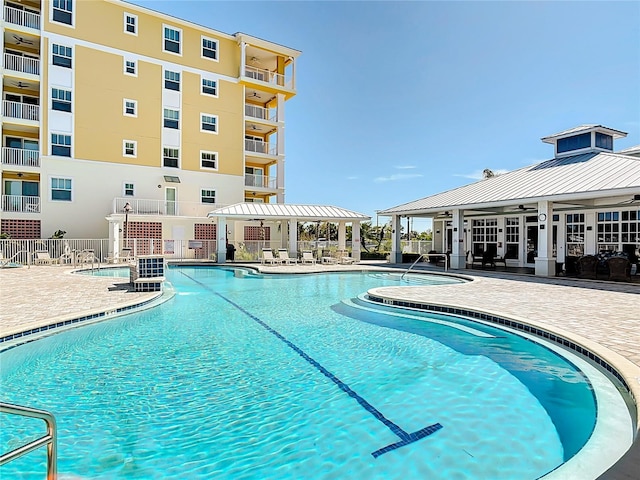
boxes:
[132,0,640,231]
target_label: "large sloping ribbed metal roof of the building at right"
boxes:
[378,152,640,215]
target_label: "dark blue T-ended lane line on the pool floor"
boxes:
[180,271,442,458]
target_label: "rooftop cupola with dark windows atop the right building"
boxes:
[542,125,627,157]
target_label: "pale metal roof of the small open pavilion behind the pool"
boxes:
[207,203,371,222]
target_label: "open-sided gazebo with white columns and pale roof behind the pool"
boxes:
[207,203,371,263]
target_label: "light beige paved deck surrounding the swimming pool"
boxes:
[0,263,640,479]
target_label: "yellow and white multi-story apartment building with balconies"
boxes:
[0,0,300,251]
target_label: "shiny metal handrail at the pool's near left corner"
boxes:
[0,402,58,480]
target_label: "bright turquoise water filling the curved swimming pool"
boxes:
[0,267,596,480]
